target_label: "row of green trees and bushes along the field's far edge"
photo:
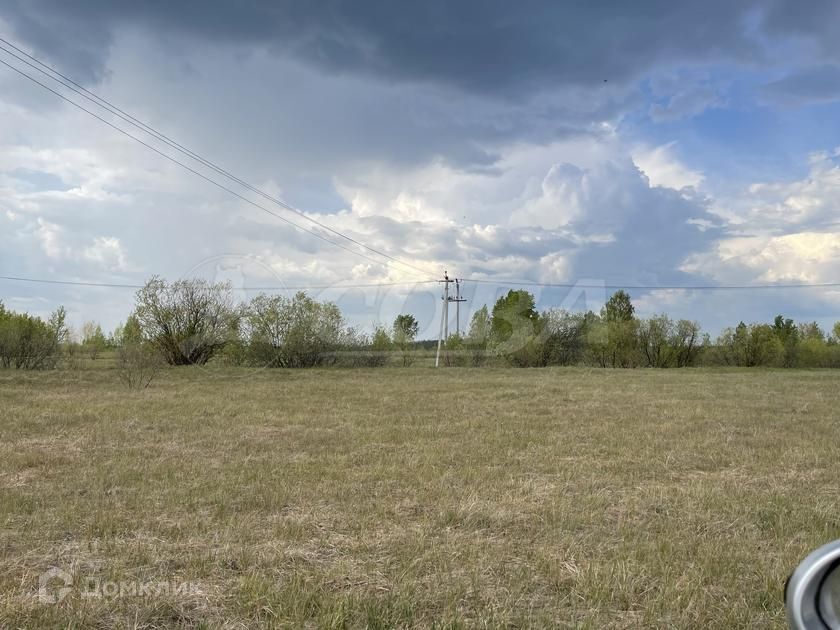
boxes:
[0,277,840,372]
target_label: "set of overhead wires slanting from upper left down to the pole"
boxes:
[0,43,430,275]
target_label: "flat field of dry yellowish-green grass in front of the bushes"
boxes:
[0,368,840,628]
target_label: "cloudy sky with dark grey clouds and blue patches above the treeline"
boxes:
[0,0,840,337]
